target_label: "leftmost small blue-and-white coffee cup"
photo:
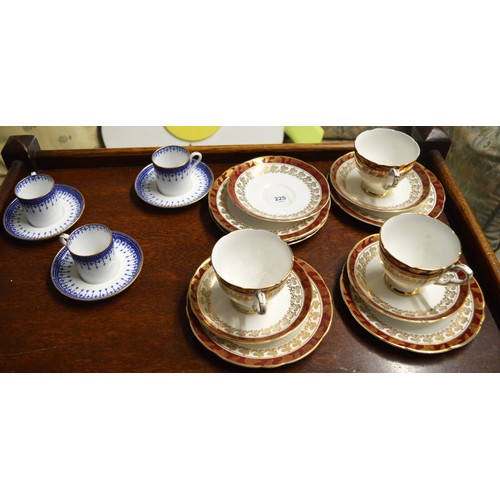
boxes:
[14,172,63,227]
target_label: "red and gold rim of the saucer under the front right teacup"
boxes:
[346,233,469,323]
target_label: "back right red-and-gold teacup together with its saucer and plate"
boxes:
[329,128,445,227]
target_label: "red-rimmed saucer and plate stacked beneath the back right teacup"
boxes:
[329,151,445,227]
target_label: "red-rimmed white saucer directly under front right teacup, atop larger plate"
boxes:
[346,234,469,322]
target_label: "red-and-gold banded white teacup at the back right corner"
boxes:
[354,128,420,196]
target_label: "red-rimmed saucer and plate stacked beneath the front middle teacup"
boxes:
[186,257,333,368]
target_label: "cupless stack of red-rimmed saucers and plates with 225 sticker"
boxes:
[208,156,331,245]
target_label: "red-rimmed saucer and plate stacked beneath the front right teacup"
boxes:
[340,234,484,353]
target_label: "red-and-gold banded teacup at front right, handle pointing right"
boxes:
[379,213,473,295]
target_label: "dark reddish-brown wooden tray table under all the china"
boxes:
[0,129,500,373]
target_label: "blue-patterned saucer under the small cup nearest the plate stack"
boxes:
[135,162,214,208]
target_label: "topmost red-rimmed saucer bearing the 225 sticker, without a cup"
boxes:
[228,156,330,222]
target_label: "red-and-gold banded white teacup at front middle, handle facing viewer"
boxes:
[212,229,293,314]
